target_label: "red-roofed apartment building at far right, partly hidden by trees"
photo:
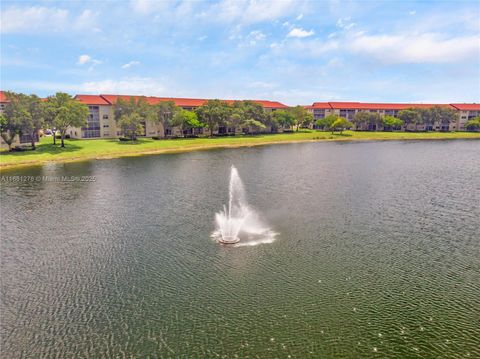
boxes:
[305,102,480,131]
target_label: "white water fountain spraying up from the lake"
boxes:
[212,166,276,246]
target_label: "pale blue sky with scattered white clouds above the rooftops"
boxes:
[0,0,480,105]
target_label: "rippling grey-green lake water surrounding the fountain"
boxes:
[1,141,480,358]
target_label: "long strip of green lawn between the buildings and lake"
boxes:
[0,130,480,169]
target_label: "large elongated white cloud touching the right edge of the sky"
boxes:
[347,33,480,63]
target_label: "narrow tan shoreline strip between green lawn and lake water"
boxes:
[0,132,480,172]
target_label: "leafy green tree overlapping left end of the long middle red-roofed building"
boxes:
[45,92,89,147]
